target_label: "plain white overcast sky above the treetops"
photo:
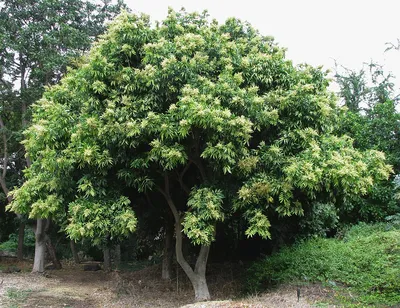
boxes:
[126,0,400,88]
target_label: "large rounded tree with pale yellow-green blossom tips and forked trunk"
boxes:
[10,10,390,300]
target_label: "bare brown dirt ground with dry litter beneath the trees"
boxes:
[0,262,335,308]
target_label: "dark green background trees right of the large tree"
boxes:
[336,63,400,221]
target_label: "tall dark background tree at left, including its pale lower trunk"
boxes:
[0,0,126,272]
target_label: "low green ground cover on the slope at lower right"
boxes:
[248,223,400,305]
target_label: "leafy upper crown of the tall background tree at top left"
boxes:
[0,0,126,88]
